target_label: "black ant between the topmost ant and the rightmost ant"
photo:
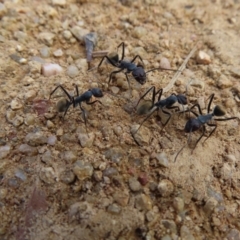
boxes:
[133,86,187,133]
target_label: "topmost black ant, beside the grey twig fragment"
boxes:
[98,42,178,95]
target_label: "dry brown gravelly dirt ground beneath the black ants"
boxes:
[0,0,240,240]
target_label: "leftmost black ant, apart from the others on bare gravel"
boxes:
[49,85,103,129]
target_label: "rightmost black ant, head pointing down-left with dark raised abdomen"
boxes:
[174,94,237,161]
